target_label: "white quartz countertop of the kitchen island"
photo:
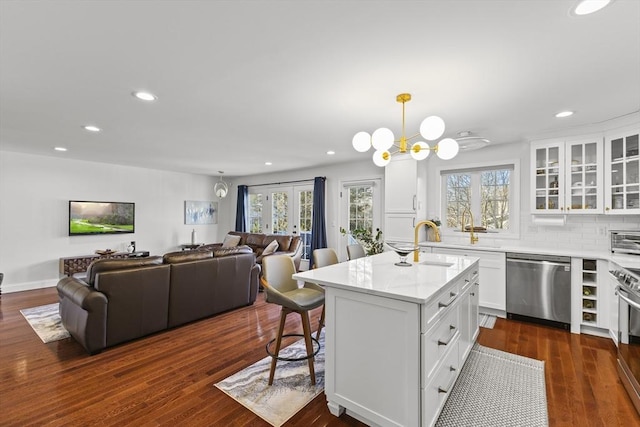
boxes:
[293,252,478,304]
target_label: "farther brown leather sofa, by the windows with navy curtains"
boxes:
[198,231,303,270]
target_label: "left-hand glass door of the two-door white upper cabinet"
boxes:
[532,141,564,213]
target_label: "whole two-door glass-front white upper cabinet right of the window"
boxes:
[531,135,604,214]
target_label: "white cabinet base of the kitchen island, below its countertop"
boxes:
[318,255,479,426]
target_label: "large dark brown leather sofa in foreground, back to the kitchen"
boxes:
[57,247,260,354]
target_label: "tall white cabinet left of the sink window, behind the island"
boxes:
[383,156,427,242]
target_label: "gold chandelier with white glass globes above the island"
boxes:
[352,93,459,167]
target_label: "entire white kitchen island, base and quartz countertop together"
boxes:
[293,252,479,426]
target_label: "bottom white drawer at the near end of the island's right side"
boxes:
[421,338,460,426]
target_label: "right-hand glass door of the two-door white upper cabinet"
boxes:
[565,139,604,213]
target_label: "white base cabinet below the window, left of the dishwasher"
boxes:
[432,247,507,316]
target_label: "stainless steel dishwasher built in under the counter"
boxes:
[507,252,571,330]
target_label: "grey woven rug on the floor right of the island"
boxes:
[436,343,549,427]
